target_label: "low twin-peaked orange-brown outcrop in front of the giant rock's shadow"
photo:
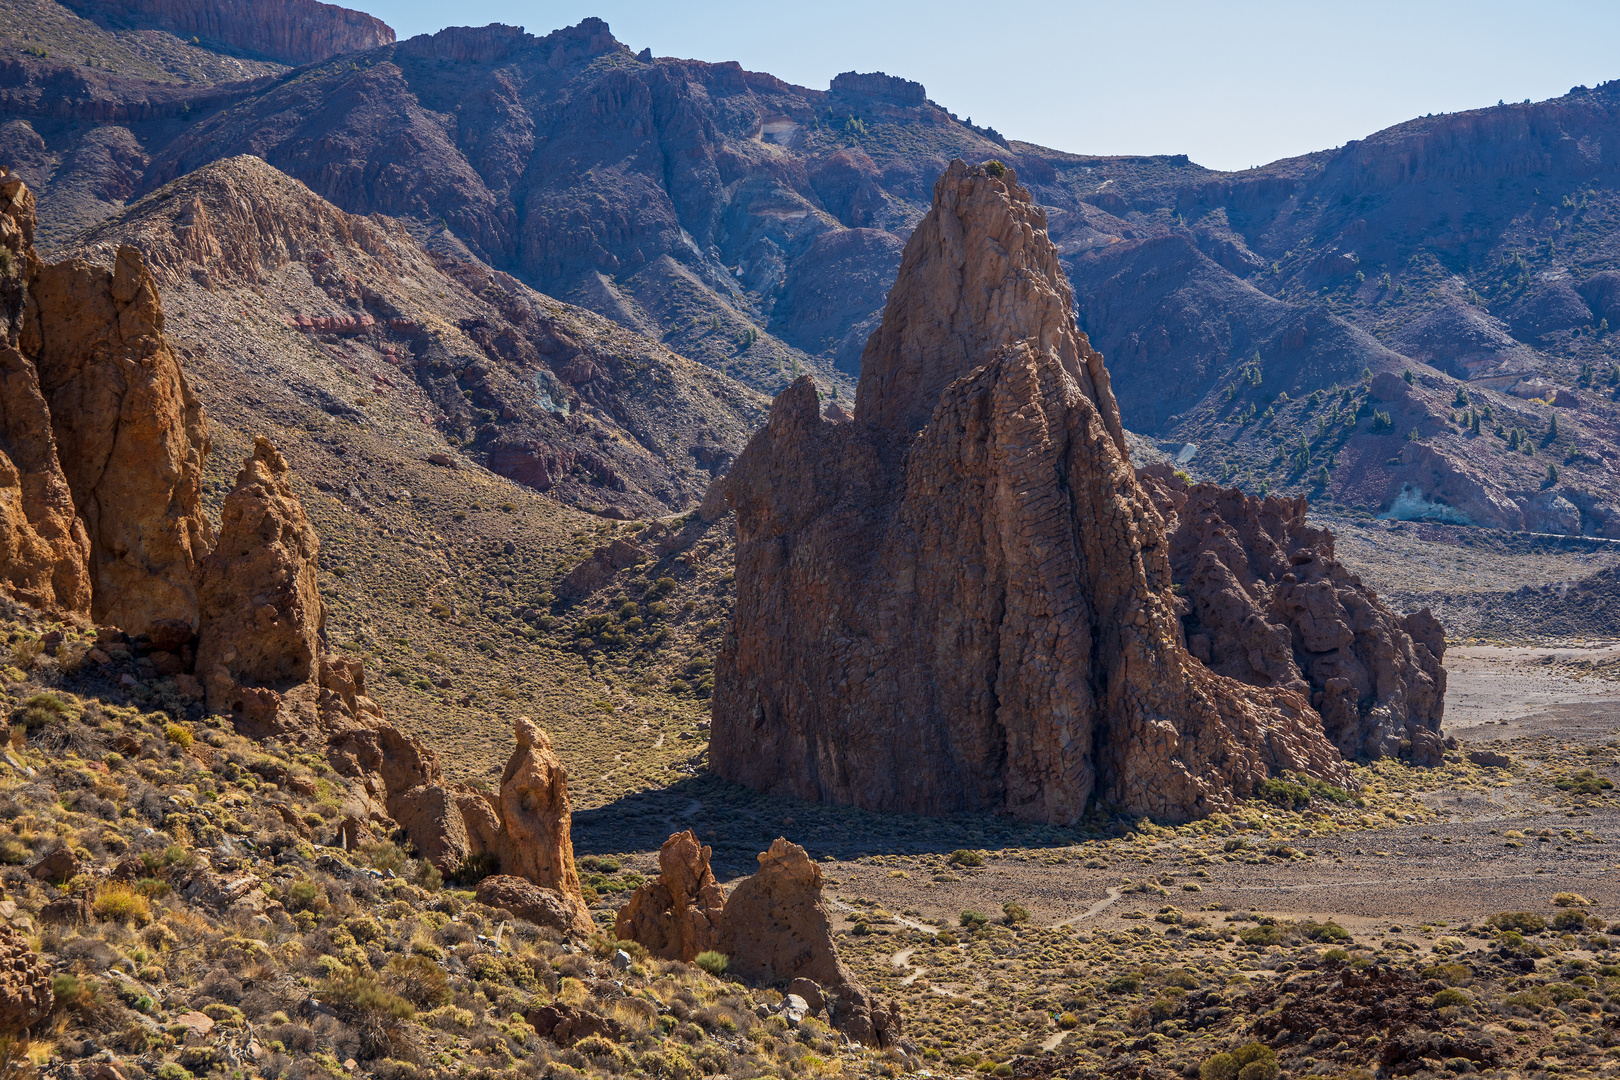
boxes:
[614,831,901,1046]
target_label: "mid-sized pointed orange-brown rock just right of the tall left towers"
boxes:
[196,436,326,738]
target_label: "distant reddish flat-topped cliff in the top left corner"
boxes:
[68,0,394,65]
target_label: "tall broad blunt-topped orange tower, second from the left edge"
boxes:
[19,239,212,635]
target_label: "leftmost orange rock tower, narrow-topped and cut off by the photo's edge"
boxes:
[0,168,91,619]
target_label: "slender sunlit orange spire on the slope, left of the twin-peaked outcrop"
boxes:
[496,716,591,934]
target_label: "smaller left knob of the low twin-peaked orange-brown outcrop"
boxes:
[614,829,726,963]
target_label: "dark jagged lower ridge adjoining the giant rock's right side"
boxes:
[1137,465,1445,764]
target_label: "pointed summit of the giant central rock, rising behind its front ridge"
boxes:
[855,159,1126,455]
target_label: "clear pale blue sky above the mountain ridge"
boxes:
[358,0,1620,168]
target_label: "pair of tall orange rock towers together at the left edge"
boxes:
[0,165,212,635]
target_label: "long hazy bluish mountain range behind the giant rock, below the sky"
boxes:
[9,7,1620,536]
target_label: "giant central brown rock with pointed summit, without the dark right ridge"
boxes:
[710,162,1348,821]
